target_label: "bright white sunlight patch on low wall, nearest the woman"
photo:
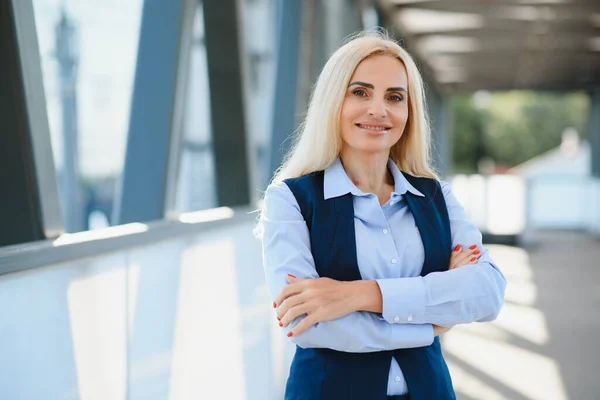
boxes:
[169,240,246,400]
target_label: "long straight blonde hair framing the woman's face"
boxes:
[273,30,439,182]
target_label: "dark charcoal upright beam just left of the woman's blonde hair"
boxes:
[203,0,251,206]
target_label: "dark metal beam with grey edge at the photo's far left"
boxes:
[0,0,64,246]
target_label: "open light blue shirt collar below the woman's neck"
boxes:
[323,157,425,200]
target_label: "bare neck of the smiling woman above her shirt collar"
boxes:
[340,149,394,197]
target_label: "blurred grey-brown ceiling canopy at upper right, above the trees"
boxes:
[379,0,600,92]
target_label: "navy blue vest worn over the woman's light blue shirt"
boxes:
[285,171,456,400]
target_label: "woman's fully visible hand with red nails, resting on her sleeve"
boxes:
[274,274,356,336]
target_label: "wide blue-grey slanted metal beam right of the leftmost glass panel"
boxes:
[113,0,197,224]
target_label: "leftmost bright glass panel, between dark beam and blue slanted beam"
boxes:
[33,0,143,232]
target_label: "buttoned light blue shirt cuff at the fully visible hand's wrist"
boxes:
[375,276,427,324]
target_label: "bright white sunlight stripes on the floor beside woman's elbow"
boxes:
[444,245,567,400]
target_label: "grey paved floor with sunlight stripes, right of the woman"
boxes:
[444,232,600,400]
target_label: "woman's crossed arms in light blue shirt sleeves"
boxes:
[263,183,506,352]
